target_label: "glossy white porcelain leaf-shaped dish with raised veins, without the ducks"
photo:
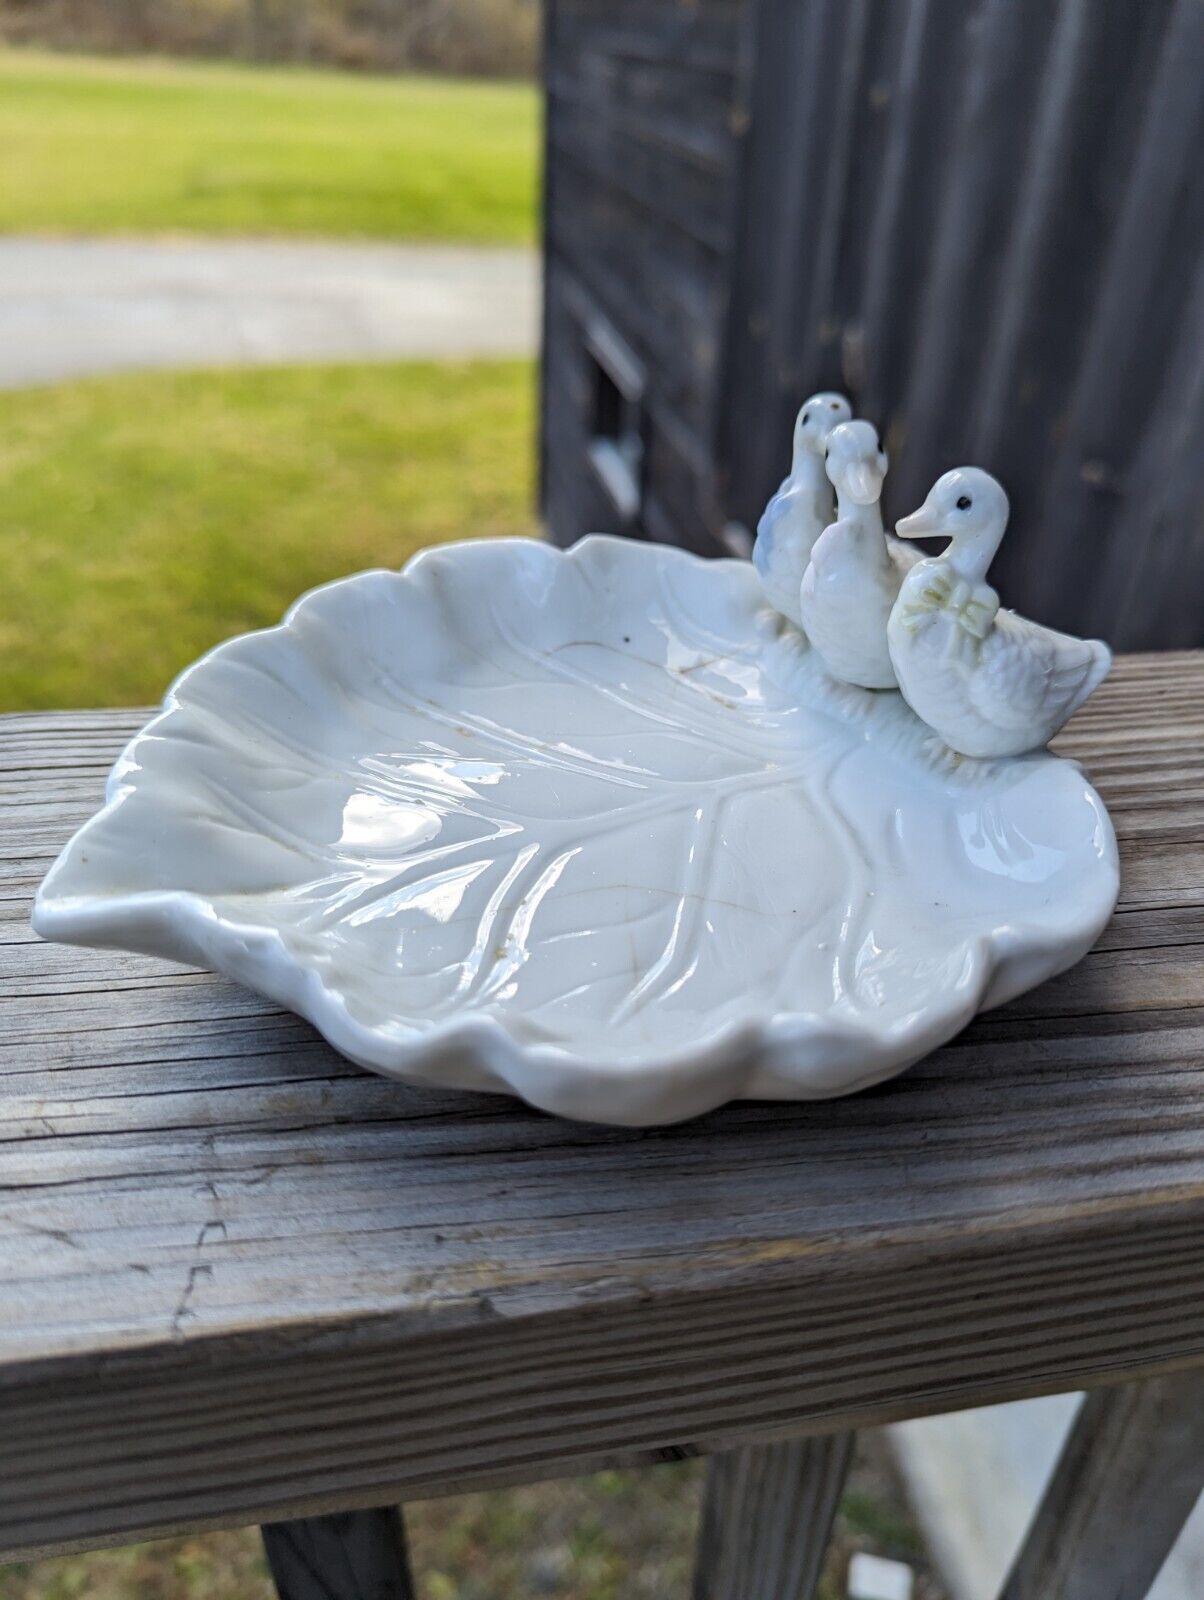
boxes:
[34,538,1118,1123]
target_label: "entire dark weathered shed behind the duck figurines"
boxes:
[541,0,1204,648]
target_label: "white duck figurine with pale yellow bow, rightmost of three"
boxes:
[887,467,1113,757]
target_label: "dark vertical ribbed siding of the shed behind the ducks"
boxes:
[719,0,1204,648]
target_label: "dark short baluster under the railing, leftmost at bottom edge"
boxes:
[261,1506,416,1600]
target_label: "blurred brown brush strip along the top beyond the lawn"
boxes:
[0,0,540,78]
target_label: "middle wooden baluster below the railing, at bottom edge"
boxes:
[693,1434,857,1600]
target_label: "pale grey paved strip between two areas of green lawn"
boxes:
[0,238,540,389]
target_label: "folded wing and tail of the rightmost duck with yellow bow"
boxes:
[967,611,1111,730]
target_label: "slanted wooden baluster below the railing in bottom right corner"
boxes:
[1001,1373,1204,1600]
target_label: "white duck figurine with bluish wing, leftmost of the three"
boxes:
[753,392,853,626]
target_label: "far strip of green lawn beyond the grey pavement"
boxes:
[0,50,538,243]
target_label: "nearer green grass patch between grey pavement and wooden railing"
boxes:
[0,362,535,710]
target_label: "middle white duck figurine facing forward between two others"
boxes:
[801,419,917,690]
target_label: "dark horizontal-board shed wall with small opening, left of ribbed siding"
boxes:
[541,0,751,554]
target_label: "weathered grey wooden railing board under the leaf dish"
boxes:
[0,654,1204,1552]
